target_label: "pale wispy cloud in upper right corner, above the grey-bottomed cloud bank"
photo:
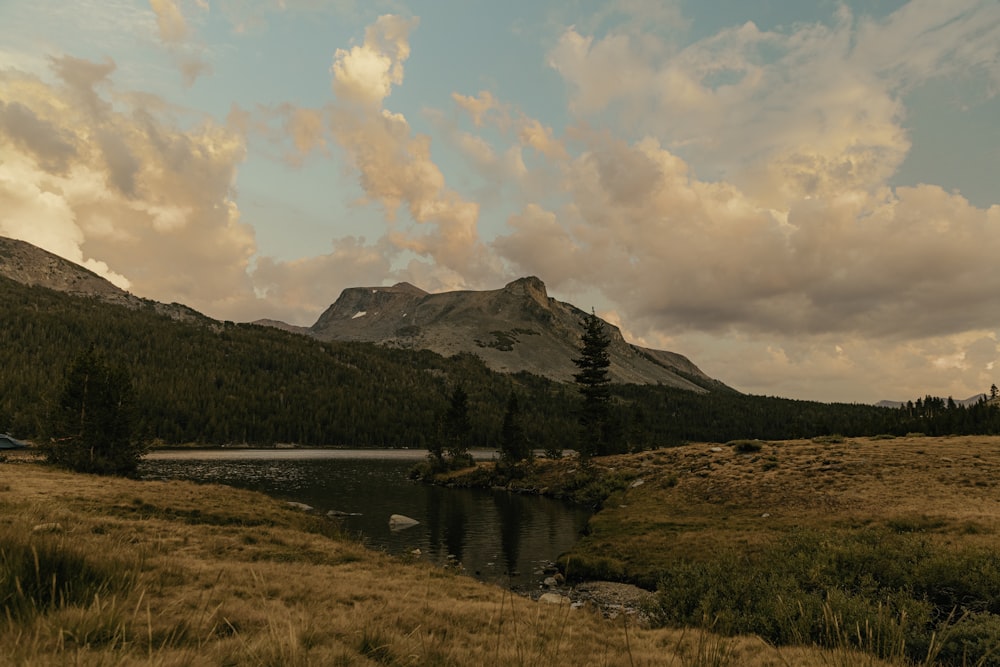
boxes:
[549,1,1000,205]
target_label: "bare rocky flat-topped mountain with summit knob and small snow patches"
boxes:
[300,277,732,393]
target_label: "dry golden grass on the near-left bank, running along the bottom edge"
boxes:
[0,463,900,666]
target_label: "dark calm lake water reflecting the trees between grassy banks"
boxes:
[140,449,590,588]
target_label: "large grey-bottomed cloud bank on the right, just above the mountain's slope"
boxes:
[494,125,1000,348]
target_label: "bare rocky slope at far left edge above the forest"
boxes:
[0,236,208,321]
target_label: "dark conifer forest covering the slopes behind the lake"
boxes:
[0,278,1000,450]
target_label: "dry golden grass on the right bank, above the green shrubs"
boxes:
[560,436,1000,579]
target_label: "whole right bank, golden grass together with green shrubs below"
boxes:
[452,437,1000,665]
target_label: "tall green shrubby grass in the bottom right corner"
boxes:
[658,528,1000,666]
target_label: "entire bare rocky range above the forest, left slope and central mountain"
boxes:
[0,237,734,393]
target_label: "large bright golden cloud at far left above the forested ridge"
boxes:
[0,57,254,310]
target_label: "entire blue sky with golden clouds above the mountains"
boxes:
[0,0,1000,403]
